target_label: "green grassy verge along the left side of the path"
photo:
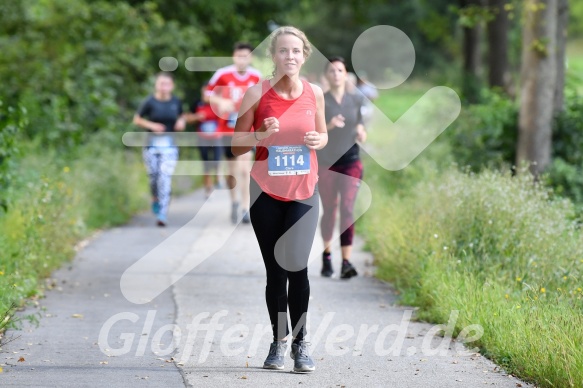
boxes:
[0,133,148,329]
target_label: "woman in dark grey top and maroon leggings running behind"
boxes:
[318,57,366,279]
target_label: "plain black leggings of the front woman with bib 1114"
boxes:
[250,178,319,340]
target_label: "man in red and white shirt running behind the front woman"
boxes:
[205,43,261,223]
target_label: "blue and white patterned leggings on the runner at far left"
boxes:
[142,147,178,219]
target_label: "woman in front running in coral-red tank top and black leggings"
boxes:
[232,27,328,372]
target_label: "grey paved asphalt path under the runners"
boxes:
[0,191,528,388]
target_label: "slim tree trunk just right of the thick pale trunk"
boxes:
[553,0,569,115]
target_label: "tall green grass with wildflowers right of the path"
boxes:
[358,85,583,387]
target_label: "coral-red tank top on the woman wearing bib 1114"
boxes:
[251,80,318,201]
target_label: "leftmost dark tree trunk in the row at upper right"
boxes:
[461,0,483,103]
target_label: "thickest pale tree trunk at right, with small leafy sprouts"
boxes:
[516,0,558,177]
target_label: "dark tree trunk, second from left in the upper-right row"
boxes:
[488,0,509,90]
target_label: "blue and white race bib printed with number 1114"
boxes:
[267,145,310,176]
